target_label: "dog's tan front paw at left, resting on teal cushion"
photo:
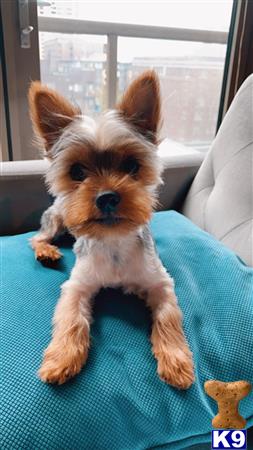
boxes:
[38,342,88,384]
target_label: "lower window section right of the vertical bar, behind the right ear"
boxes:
[118,38,226,150]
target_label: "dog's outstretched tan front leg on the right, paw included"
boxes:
[147,280,194,389]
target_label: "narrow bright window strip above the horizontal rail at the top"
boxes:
[39,0,232,31]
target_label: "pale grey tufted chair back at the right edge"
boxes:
[183,75,253,266]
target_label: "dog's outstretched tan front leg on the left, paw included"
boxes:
[39,279,93,384]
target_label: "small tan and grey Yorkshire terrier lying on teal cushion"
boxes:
[29,71,194,389]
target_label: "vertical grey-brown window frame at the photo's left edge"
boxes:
[0,0,40,161]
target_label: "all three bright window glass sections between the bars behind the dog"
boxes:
[38,0,232,151]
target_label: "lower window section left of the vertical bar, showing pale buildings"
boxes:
[39,32,106,115]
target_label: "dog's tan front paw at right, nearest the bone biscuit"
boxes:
[156,347,194,389]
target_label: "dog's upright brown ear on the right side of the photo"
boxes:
[117,70,161,142]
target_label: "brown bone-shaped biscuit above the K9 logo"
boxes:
[204,380,251,429]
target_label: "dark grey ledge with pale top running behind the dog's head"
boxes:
[0,152,203,235]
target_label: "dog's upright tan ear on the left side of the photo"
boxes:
[28,81,80,150]
